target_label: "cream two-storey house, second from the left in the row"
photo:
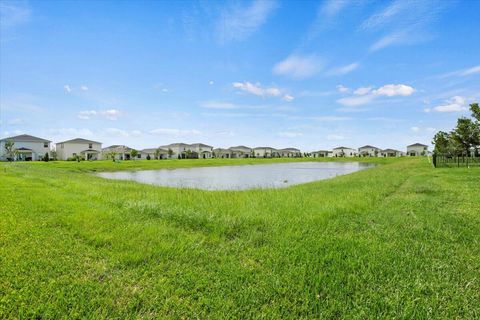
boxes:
[56,138,102,160]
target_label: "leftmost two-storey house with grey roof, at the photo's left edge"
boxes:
[0,134,51,161]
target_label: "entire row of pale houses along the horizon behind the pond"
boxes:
[0,134,428,161]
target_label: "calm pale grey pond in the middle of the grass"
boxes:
[97,162,375,190]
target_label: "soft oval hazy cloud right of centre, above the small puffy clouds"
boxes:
[273,55,322,79]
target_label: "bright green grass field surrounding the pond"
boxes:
[0,158,480,319]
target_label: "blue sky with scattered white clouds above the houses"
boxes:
[0,0,480,151]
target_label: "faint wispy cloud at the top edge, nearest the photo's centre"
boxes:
[217,0,277,43]
